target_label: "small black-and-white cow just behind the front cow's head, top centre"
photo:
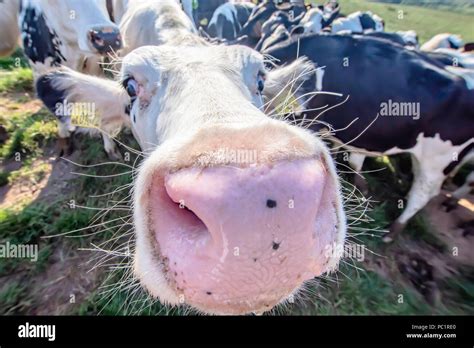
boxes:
[207,2,255,41]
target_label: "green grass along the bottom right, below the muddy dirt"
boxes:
[290,265,474,315]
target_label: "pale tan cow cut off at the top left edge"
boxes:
[0,0,20,57]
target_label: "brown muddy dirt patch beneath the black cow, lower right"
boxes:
[364,192,474,305]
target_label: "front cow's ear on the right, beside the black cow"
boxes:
[263,58,316,111]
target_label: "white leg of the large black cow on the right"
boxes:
[383,155,449,243]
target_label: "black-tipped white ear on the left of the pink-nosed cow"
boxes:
[36,68,129,124]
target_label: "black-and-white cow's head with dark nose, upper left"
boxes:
[20,0,122,55]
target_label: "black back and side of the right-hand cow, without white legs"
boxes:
[266,35,474,152]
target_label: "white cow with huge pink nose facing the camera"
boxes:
[32,0,346,314]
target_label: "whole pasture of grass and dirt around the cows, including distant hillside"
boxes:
[0,0,474,315]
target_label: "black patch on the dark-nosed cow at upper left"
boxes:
[20,7,66,66]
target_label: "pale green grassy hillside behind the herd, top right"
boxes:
[339,0,474,42]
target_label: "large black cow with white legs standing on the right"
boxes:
[264,35,474,242]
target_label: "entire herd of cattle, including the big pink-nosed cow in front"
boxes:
[0,0,474,313]
